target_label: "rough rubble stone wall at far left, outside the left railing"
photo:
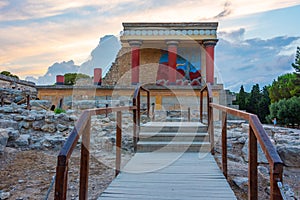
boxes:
[0,104,77,153]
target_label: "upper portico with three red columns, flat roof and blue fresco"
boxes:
[104,22,218,85]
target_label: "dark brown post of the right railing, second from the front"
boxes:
[248,126,258,200]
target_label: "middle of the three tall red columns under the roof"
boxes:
[167,41,178,85]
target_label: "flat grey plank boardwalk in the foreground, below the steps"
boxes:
[99,152,236,200]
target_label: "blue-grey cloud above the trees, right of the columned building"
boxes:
[216,29,300,91]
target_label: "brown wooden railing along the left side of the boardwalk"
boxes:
[54,86,150,200]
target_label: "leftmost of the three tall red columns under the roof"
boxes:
[129,41,142,85]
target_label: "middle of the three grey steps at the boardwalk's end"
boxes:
[139,132,209,142]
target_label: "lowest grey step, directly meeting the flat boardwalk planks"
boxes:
[137,141,210,152]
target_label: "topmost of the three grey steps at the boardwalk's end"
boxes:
[141,122,207,133]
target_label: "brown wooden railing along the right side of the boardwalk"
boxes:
[200,84,283,200]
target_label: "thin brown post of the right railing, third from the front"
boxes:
[222,112,227,178]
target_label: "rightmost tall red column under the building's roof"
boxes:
[203,40,217,84]
